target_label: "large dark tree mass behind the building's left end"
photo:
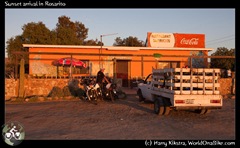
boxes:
[6,16,90,65]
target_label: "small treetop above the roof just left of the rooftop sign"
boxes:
[113,36,144,47]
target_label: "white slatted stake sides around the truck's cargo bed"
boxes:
[152,68,220,95]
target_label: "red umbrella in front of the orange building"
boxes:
[52,57,86,68]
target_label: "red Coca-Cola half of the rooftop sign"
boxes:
[174,33,205,48]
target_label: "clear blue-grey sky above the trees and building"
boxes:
[5,8,236,57]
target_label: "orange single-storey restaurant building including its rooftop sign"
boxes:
[23,32,213,86]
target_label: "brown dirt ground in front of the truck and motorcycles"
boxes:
[5,95,236,140]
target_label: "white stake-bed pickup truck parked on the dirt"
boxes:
[137,68,223,115]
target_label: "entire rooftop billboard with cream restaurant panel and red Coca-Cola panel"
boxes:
[147,32,205,48]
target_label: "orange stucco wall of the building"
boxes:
[29,46,207,78]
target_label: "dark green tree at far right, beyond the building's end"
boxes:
[211,47,235,71]
